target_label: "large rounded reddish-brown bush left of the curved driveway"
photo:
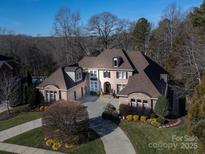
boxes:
[42,100,89,145]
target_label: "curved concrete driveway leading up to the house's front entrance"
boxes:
[81,96,135,154]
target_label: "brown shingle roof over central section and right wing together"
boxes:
[79,49,167,97]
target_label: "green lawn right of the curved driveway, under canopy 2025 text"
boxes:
[120,122,196,154]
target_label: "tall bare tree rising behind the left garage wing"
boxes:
[54,7,86,64]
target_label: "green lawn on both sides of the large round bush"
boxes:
[5,127,105,154]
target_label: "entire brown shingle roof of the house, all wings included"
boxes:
[39,49,167,97]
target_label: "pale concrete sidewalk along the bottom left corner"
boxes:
[0,143,64,154]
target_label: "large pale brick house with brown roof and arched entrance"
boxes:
[37,49,179,115]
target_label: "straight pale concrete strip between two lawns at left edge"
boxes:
[0,119,42,142]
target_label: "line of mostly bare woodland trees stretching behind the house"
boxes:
[0,2,205,98]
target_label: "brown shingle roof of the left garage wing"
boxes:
[38,67,85,90]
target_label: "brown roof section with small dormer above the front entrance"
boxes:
[79,49,134,70]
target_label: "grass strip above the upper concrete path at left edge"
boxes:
[0,112,41,131]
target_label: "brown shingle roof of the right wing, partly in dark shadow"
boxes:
[119,51,167,97]
